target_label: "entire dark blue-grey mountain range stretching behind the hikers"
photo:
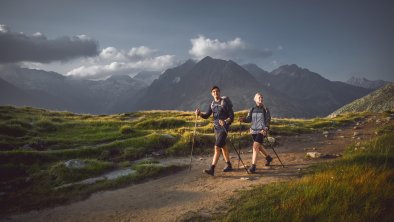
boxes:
[0,57,378,117]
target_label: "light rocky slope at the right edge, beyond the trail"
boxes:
[330,83,394,116]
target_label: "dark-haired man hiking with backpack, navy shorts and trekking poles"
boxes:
[195,86,234,176]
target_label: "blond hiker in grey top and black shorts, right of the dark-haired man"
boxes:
[239,93,272,173]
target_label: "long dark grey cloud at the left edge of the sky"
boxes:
[0,25,99,63]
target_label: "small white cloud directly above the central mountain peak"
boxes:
[189,35,272,61]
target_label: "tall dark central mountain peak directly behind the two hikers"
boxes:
[135,57,310,117]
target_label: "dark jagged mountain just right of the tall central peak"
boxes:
[247,64,371,117]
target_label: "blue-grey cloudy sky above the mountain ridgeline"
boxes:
[0,0,394,81]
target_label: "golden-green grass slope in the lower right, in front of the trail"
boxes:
[216,127,394,221]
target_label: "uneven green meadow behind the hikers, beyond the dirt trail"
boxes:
[0,106,376,215]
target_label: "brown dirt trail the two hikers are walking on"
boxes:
[5,117,382,222]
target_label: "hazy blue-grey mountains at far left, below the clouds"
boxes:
[0,67,147,114]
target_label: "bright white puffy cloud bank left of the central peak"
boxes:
[67,46,176,79]
